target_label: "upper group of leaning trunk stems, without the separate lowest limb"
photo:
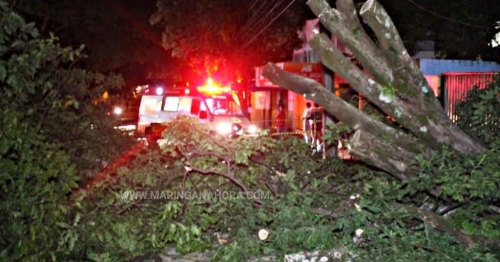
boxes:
[304,0,485,155]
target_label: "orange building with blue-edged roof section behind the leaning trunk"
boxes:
[251,19,500,131]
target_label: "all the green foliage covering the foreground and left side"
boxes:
[0,5,500,261]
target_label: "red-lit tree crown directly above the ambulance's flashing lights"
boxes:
[151,0,307,85]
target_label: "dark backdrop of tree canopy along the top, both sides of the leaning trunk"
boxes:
[7,0,500,85]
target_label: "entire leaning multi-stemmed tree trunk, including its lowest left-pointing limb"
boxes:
[263,0,485,178]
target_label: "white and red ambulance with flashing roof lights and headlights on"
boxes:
[138,79,258,137]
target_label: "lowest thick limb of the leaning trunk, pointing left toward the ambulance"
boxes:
[263,62,432,178]
